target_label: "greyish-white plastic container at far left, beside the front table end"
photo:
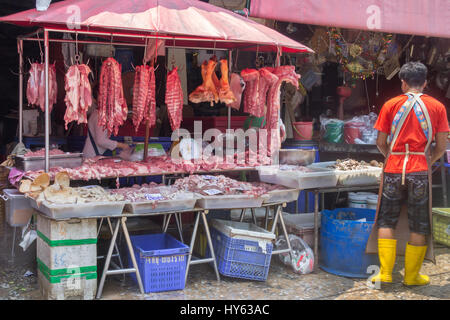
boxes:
[3,189,34,227]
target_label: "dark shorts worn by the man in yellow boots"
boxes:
[377,172,430,235]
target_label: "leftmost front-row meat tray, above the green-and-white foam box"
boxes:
[30,199,128,219]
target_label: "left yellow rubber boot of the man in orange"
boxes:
[371,239,397,283]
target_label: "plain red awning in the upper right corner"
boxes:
[250,0,450,38]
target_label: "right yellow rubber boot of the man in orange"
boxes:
[403,243,430,286]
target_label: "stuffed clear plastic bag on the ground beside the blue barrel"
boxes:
[275,234,314,274]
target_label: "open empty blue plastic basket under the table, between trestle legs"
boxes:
[129,233,189,293]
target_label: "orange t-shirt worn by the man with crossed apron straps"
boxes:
[374,94,449,173]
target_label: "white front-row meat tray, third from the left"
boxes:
[197,195,264,209]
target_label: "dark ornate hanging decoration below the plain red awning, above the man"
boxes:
[328,28,392,87]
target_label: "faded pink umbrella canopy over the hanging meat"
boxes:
[0,0,314,52]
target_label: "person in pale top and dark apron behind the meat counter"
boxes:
[83,88,130,159]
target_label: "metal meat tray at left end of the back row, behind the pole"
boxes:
[15,153,83,171]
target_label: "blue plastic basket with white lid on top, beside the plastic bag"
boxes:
[210,227,273,281]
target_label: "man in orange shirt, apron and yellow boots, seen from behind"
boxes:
[367,62,449,285]
